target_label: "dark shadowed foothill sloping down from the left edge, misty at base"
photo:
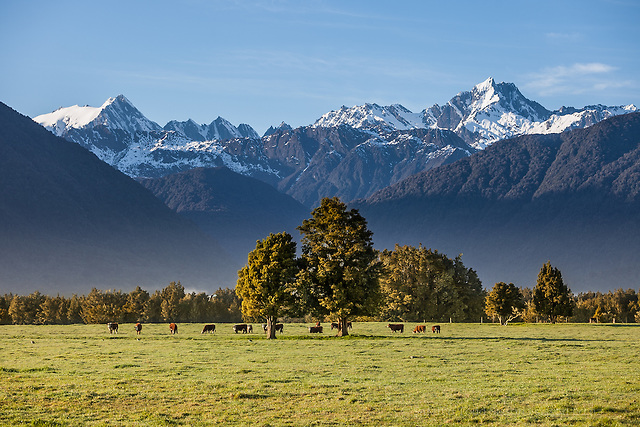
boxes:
[0,103,236,294]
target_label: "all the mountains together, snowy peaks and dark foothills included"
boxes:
[0,79,640,293]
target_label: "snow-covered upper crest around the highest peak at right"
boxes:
[313,77,637,149]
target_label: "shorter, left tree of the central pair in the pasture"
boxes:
[236,232,298,339]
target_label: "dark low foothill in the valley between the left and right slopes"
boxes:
[139,167,309,270]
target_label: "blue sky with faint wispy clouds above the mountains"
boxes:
[0,0,640,134]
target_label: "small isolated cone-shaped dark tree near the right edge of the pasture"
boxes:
[533,261,573,323]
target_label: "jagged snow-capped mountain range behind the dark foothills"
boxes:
[34,78,637,208]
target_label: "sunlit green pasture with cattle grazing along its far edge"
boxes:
[0,323,640,426]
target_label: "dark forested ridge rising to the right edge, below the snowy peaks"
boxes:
[352,113,640,292]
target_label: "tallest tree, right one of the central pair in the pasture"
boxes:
[298,197,381,336]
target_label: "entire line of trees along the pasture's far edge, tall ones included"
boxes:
[0,198,640,330]
